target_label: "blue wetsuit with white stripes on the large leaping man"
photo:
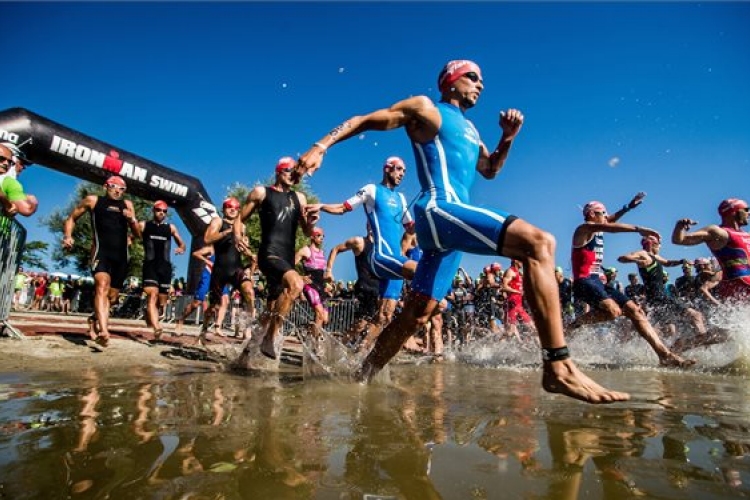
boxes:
[412,102,515,300]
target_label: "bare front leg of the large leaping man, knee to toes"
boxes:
[501,219,630,403]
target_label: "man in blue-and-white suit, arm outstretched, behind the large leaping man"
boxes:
[316,156,417,344]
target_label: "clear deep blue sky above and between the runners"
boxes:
[0,2,750,279]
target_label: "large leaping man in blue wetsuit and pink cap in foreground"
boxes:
[297,60,630,403]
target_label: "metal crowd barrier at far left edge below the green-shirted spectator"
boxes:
[0,215,26,339]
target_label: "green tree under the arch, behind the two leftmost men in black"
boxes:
[41,182,151,278]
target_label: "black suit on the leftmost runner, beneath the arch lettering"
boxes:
[91,196,128,290]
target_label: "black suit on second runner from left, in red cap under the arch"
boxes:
[143,220,172,294]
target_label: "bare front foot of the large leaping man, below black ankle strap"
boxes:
[542,359,630,404]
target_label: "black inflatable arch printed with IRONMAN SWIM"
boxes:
[0,108,217,290]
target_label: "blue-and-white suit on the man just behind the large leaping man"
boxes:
[344,184,413,299]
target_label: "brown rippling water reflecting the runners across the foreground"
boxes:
[0,363,750,499]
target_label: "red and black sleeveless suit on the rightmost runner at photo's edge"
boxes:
[711,226,750,300]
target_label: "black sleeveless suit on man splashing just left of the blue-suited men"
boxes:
[258,186,302,300]
